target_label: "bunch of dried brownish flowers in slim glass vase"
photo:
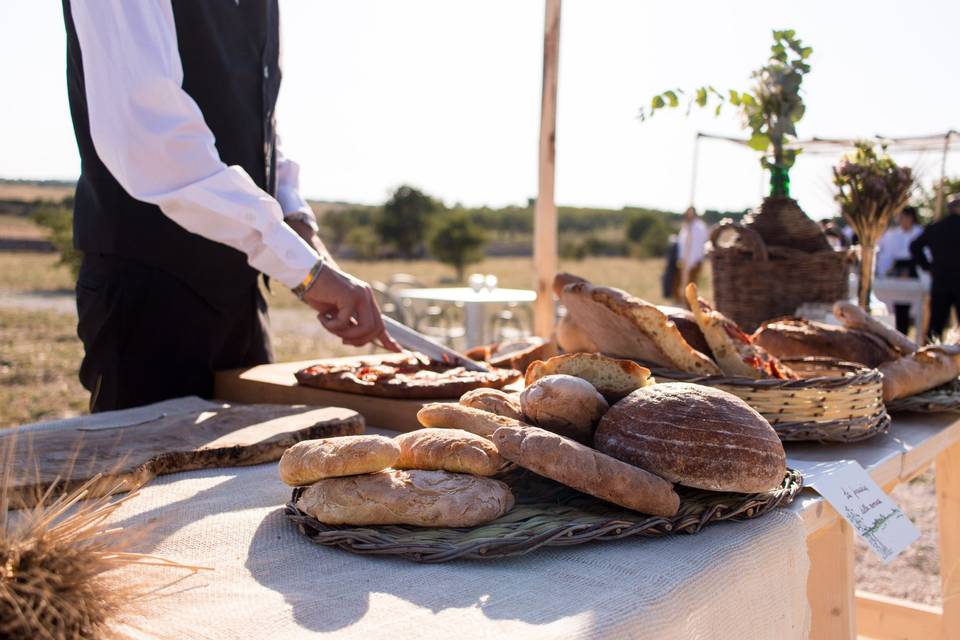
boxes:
[833,140,914,313]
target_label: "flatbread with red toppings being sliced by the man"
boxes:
[296,354,521,399]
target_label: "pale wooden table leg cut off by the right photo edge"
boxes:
[936,444,960,640]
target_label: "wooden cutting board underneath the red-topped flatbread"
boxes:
[213,356,438,431]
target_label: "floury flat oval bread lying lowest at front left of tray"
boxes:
[297,469,513,527]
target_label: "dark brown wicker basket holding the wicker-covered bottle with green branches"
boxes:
[710,199,848,331]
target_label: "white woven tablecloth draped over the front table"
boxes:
[30,400,809,640]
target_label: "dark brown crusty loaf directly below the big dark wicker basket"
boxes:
[753,318,899,369]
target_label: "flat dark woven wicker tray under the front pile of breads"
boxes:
[285,469,803,562]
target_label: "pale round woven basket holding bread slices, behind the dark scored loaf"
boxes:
[644,358,890,442]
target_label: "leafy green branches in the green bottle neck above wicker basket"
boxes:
[639,29,813,198]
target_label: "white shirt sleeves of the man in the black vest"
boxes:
[70,0,318,288]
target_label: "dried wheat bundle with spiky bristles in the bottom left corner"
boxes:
[0,447,201,640]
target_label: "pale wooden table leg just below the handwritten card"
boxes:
[807,517,856,640]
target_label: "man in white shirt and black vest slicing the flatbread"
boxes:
[63,0,398,411]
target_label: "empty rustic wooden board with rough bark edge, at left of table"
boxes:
[0,404,364,506]
